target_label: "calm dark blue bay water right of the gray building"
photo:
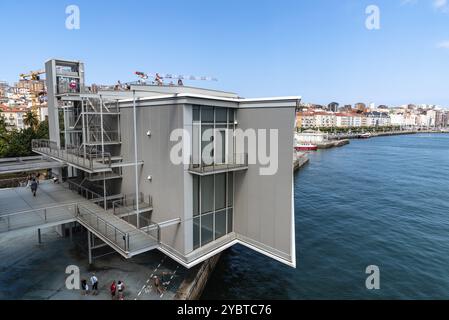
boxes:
[203,134,449,299]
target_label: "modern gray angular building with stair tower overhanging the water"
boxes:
[33,60,300,268]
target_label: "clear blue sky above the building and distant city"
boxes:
[0,0,449,106]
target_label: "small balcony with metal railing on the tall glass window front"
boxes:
[189,153,248,174]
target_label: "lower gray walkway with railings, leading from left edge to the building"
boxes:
[0,182,159,258]
